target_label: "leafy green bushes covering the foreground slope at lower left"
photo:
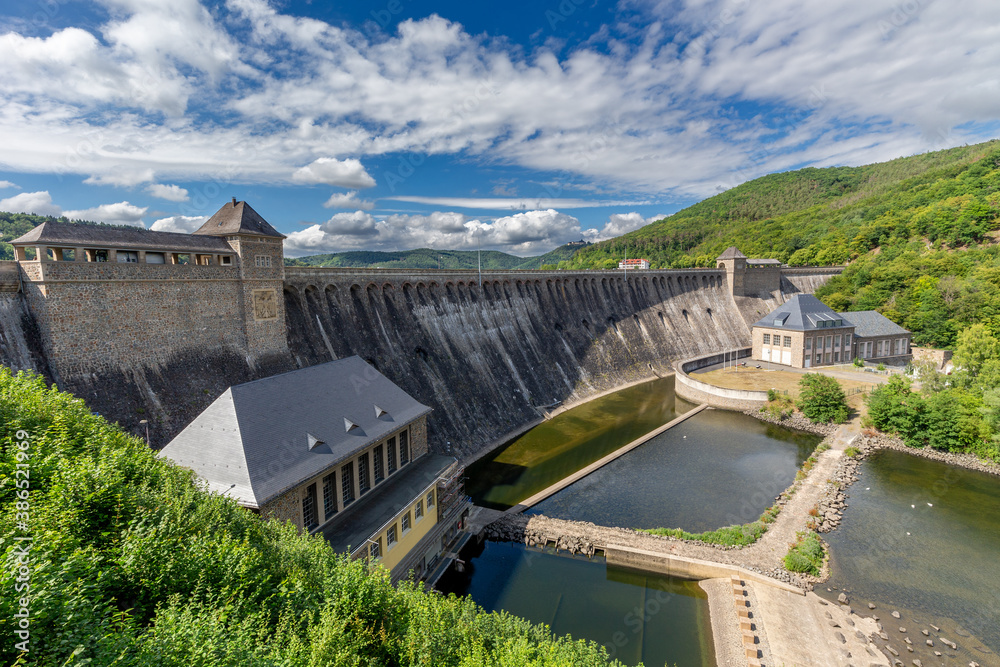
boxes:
[0,368,620,667]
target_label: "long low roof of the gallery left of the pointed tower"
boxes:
[11,220,234,254]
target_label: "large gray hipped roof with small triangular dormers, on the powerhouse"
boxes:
[160,357,431,507]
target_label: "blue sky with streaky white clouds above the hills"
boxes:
[0,0,1000,256]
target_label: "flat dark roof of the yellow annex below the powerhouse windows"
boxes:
[320,454,455,552]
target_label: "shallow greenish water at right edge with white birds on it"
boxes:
[817,450,1000,665]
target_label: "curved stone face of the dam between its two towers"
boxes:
[284,268,832,454]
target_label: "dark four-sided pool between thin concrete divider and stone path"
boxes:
[526,410,822,532]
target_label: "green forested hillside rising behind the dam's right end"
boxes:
[560,141,1000,268]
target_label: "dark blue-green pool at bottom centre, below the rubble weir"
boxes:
[437,542,715,667]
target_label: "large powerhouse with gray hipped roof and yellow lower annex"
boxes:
[159,356,469,577]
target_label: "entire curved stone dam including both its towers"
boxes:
[0,200,839,455]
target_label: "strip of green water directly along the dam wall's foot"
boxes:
[466,377,694,509]
